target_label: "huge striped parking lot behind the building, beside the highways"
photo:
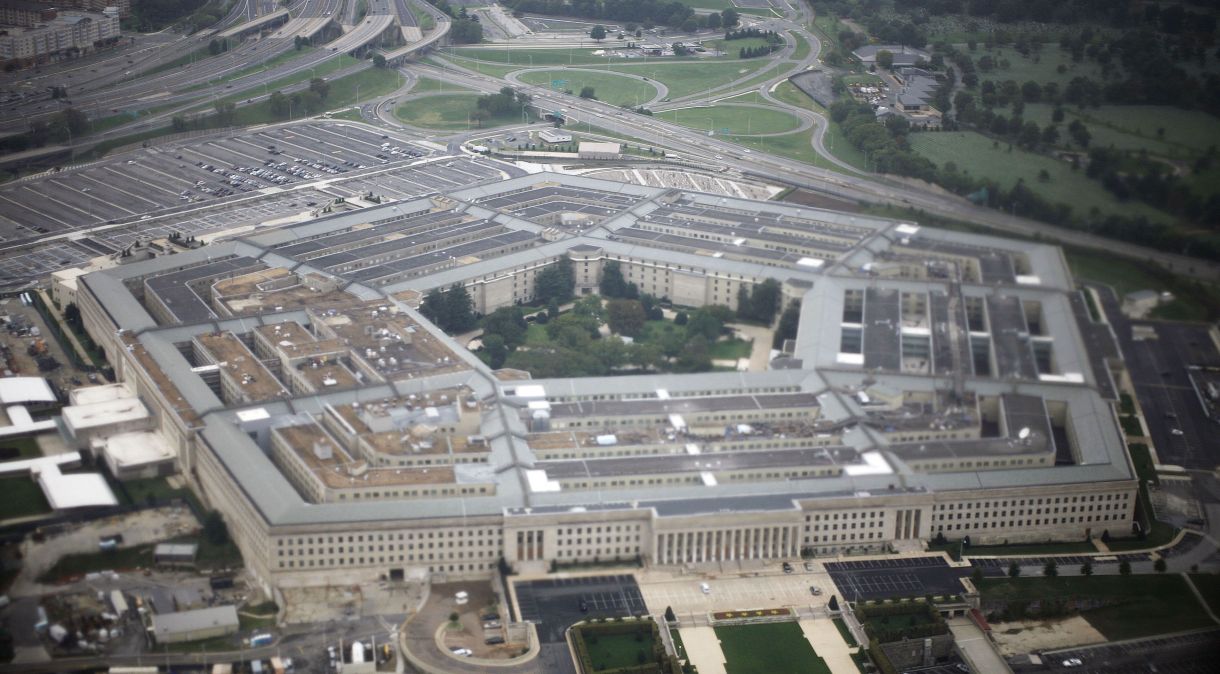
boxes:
[0,122,516,284]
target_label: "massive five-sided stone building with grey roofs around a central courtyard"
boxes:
[79,175,1137,585]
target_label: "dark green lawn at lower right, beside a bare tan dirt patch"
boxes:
[980,575,1213,641]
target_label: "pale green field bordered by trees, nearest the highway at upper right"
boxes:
[908,131,1172,222]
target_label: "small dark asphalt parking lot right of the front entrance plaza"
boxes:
[826,557,970,601]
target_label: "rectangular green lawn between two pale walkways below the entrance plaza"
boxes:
[715,623,831,674]
